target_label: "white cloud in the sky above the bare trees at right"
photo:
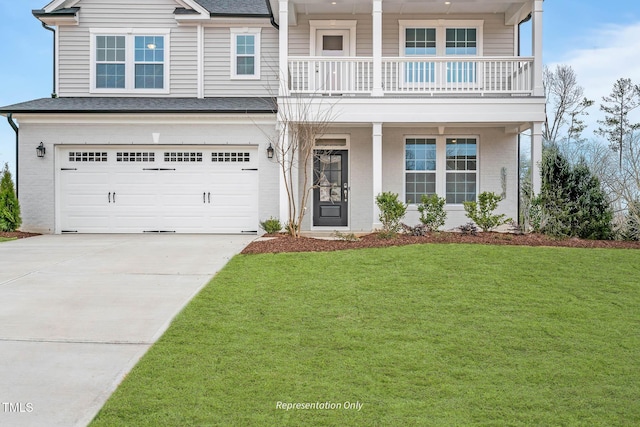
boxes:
[548,22,640,136]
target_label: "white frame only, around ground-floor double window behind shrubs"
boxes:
[402,134,480,206]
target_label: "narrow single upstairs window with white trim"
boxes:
[230,28,261,79]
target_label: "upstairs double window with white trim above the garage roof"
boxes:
[91,29,169,94]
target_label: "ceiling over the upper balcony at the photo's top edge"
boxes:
[270,0,531,16]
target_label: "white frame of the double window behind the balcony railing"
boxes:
[398,19,484,87]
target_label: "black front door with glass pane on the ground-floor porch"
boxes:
[313,150,349,227]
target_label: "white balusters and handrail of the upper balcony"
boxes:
[289,56,533,95]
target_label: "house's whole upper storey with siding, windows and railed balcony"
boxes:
[36,0,542,98]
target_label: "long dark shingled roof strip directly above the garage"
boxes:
[0,97,277,114]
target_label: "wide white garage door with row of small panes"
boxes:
[57,146,258,233]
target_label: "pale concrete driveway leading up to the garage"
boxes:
[0,235,255,427]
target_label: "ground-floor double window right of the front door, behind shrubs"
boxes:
[404,136,478,204]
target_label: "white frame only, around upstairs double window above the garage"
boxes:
[89,28,171,95]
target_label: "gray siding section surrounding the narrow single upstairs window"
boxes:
[204,25,278,97]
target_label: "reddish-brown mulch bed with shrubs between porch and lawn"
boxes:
[242,232,640,254]
